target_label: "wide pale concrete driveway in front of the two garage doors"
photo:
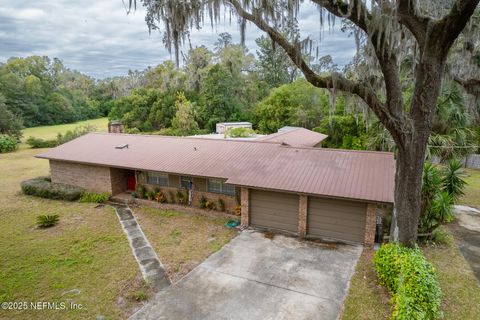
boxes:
[131,230,362,320]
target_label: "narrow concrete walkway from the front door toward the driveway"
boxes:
[111,203,170,292]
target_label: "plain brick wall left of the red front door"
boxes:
[50,160,112,193]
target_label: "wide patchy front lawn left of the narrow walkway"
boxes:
[0,149,143,319]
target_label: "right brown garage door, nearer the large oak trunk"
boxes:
[307,197,367,242]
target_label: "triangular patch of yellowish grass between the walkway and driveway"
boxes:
[133,207,236,282]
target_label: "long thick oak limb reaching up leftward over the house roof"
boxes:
[228,0,403,142]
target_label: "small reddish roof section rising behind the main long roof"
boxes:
[257,128,328,147]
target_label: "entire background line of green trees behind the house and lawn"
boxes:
[0,33,480,159]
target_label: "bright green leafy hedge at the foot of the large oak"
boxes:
[374,243,442,320]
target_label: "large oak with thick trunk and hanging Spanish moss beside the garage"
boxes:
[135,0,480,246]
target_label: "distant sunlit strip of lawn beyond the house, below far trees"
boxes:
[22,118,108,140]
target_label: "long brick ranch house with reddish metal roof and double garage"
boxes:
[37,133,395,245]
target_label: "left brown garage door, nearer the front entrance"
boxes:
[250,190,298,233]
